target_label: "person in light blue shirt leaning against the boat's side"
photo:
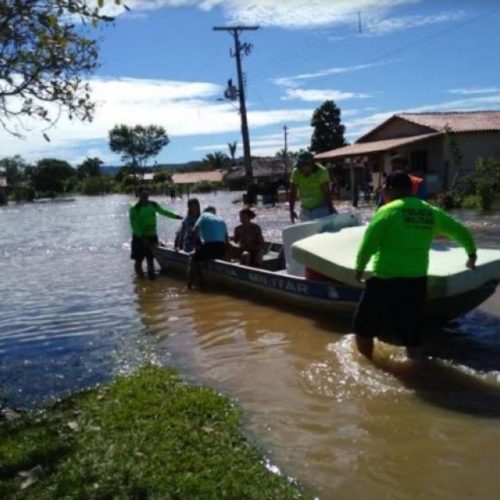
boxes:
[187,207,229,288]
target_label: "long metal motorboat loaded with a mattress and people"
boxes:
[155,214,499,325]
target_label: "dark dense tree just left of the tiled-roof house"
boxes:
[310,101,346,153]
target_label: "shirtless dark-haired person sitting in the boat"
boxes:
[231,208,264,267]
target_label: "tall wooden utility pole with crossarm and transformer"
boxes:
[213,26,259,197]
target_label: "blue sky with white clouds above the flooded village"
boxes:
[0,0,500,165]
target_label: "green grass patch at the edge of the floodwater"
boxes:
[0,366,303,500]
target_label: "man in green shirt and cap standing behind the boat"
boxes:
[290,151,335,224]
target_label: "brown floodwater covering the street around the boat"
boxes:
[0,193,500,499]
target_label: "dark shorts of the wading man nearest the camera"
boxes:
[354,277,427,347]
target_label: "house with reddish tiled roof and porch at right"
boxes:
[316,111,500,194]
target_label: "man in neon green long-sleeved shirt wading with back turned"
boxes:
[354,171,476,358]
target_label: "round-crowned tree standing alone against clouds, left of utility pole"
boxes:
[109,125,170,188]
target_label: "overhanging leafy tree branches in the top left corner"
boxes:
[0,0,120,138]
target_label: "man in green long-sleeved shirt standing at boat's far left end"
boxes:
[129,187,182,279]
